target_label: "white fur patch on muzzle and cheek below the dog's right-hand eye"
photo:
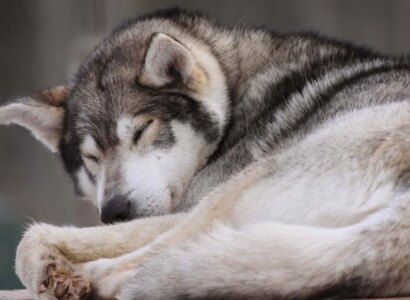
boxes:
[121,121,213,213]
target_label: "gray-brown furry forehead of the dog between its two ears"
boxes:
[67,32,156,120]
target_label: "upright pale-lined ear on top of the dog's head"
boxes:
[138,33,207,91]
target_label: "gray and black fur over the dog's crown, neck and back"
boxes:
[62,11,409,210]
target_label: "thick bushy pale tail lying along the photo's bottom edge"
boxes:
[121,203,410,300]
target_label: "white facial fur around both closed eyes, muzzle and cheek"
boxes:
[78,116,215,214]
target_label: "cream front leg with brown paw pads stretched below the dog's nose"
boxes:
[16,214,184,300]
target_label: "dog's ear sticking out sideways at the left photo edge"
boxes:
[0,86,69,152]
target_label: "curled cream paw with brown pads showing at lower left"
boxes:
[16,224,91,300]
